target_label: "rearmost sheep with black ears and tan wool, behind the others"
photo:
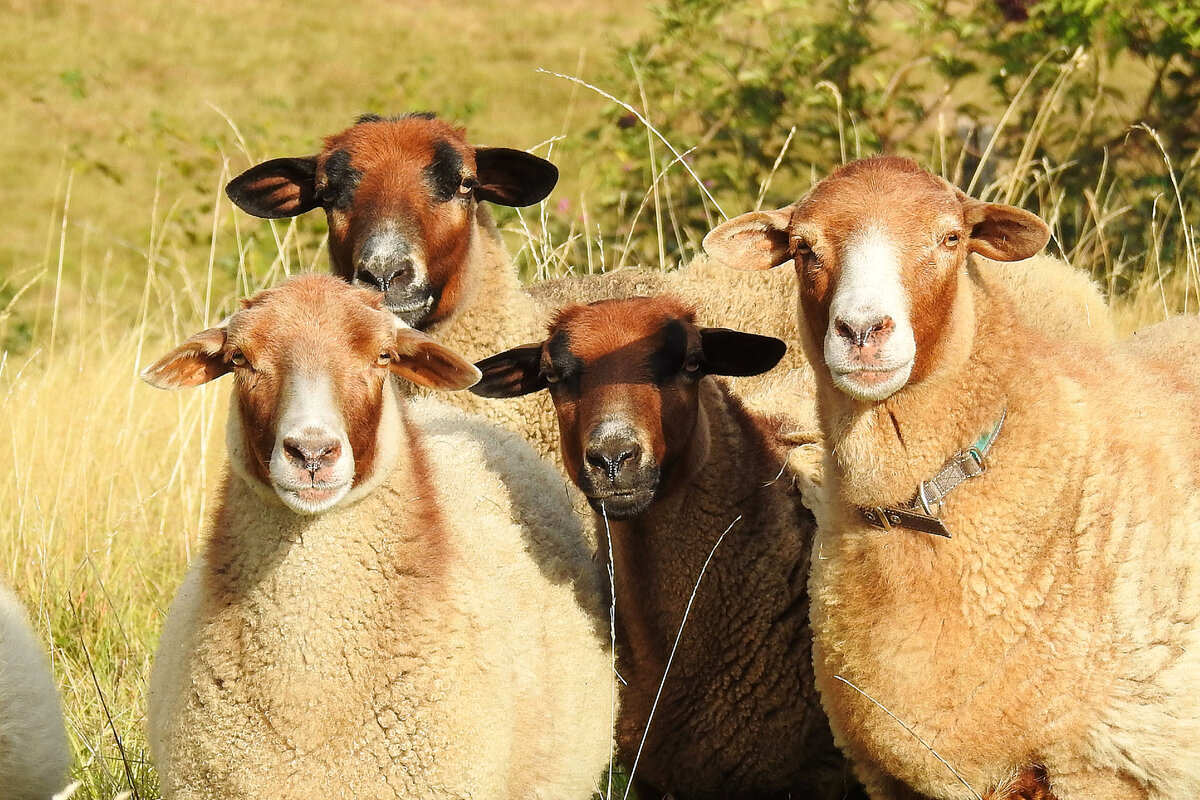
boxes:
[226,113,1112,474]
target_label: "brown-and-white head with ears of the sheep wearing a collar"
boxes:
[704,157,1049,402]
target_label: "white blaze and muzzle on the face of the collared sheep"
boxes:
[824,225,917,401]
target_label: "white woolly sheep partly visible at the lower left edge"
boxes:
[0,581,71,800]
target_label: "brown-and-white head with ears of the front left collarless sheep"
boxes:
[142,276,479,513]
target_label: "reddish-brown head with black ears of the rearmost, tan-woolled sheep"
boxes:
[226,114,558,329]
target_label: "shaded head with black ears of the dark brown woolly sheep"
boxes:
[474,296,786,519]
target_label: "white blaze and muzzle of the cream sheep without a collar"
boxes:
[270,374,354,513]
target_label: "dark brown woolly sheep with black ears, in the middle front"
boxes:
[472,295,848,800]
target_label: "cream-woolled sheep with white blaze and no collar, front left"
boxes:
[143,276,613,800]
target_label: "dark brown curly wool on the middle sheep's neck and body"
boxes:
[610,379,853,800]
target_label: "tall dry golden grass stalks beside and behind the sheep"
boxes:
[0,68,1200,800]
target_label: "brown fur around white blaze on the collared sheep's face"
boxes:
[790,157,968,383]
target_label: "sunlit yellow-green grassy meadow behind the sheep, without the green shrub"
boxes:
[0,0,1200,800]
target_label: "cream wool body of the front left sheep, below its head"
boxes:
[150,399,612,800]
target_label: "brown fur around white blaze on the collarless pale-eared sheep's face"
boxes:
[226,276,395,485]
